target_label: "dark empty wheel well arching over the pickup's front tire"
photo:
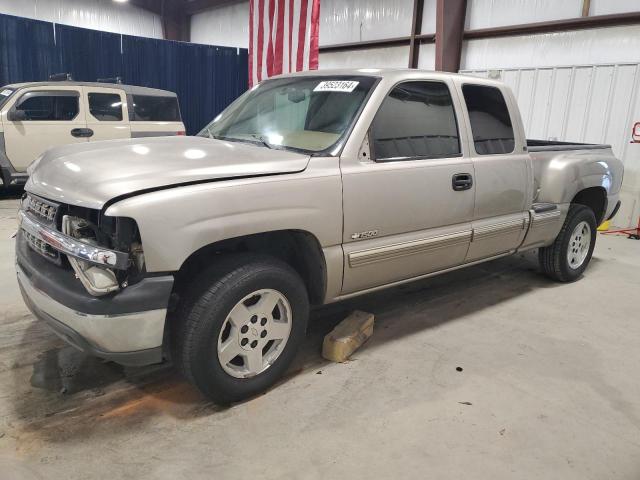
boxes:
[176,230,327,305]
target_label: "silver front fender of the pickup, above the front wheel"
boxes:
[105,158,342,272]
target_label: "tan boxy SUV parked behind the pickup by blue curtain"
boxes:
[0,81,185,186]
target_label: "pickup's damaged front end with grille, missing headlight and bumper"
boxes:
[16,193,174,365]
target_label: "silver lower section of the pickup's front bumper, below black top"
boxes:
[16,265,167,365]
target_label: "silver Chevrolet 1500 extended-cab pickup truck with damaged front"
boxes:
[16,69,623,403]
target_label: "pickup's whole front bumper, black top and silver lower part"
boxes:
[16,231,173,365]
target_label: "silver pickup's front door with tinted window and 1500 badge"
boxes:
[341,80,475,294]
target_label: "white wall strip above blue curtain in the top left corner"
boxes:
[0,0,162,38]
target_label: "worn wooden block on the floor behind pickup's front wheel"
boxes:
[322,310,374,362]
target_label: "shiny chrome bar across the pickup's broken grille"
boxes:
[18,210,129,270]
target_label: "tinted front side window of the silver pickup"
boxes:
[371,82,460,160]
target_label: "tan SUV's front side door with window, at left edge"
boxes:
[2,86,88,172]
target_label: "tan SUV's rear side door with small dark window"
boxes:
[82,87,131,142]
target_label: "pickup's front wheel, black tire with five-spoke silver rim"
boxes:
[172,255,309,404]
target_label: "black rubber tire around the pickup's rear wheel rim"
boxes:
[538,204,597,282]
